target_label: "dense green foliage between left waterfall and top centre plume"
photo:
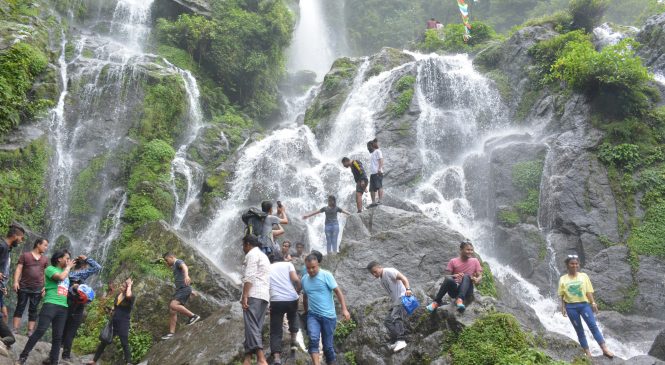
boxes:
[157,0,293,117]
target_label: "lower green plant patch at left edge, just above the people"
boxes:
[0,138,49,232]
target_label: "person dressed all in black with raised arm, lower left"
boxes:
[88,278,136,365]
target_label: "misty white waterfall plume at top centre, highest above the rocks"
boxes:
[287,0,339,81]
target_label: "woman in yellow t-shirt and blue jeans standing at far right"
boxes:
[558,255,614,359]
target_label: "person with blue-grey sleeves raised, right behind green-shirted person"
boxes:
[62,255,102,360]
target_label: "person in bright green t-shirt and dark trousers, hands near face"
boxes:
[18,250,74,364]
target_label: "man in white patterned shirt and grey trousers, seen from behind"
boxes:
[240,235,272,365]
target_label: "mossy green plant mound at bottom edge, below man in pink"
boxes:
[450,313,557,365]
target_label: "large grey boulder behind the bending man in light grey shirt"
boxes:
[324,206,464,307]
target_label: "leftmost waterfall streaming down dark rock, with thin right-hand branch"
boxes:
[49,0,202,258]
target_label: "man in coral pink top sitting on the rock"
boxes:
[427,240,483,313]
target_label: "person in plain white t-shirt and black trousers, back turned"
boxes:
[270,257,300,364]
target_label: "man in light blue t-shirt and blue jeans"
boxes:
[302,254,351,365]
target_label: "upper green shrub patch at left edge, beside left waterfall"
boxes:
[0,42,51,136]
